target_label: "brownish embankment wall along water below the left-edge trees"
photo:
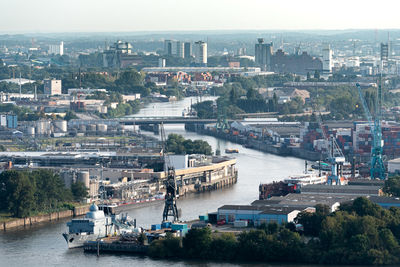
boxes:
[0,206,89,231]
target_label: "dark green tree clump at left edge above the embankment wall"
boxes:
[0,170,87,218]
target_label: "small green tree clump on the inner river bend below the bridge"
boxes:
[166,134,212,155]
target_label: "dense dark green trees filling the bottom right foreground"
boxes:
[149,198,400,265]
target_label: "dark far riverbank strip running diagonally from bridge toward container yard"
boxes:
[185,124,321,161]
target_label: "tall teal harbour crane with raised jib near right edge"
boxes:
[356,81,386,180]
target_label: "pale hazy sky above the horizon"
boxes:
[0,0,400,33]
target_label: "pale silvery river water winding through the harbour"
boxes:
[0,97,304,266]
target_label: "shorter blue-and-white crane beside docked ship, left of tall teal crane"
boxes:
[314,108,345,185]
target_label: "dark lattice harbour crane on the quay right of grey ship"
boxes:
[160,123,179,222]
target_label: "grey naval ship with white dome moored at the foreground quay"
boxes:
[62,204,136,248]
